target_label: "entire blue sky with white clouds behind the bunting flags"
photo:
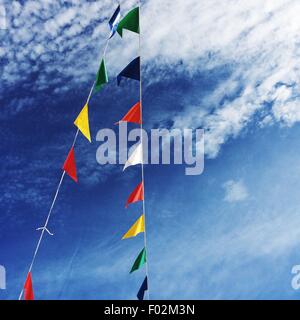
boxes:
[0,0,300,299]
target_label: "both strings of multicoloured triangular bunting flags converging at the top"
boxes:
[19,5,150,300]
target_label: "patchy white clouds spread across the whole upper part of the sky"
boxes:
[0,0,300,158]
